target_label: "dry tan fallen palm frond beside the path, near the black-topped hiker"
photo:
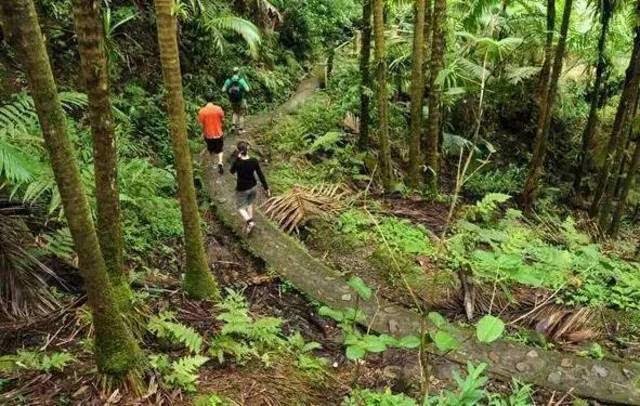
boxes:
[262,184,349,233]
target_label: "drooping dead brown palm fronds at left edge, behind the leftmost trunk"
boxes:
[0,214,61,320]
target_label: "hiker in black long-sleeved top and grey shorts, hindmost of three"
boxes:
[231,141,271,234]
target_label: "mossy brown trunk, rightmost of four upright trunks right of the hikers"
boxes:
[425,0,447,193]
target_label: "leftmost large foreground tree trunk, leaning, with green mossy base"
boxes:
[0,0,142,376]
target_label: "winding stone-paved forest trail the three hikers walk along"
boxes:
[201,69,640,405]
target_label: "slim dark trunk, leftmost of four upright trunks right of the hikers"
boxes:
[358,0,372,150]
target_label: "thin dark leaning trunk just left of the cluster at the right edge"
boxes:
[573,7,611,196]
